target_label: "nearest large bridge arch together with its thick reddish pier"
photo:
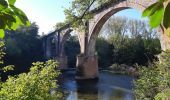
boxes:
[76,0,170,79]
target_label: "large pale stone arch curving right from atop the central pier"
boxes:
[87,0,157,56]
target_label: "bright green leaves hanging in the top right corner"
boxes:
[143,0,170,36]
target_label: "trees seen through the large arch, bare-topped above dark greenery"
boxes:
[101,17,161,65]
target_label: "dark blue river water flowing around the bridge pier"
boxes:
[60,71,135,100]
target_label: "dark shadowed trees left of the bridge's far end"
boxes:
[4,23,43,74]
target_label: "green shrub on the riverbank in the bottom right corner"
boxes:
[134,50,170,100]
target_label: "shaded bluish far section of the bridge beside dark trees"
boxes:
[43,27,72,69]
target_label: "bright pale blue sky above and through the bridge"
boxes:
[15,0,144,35]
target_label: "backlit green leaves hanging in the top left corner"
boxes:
[0,0,30,38]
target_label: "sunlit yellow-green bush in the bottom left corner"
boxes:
[0,60,62,100]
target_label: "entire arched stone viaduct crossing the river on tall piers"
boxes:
[44,0,170,79]
